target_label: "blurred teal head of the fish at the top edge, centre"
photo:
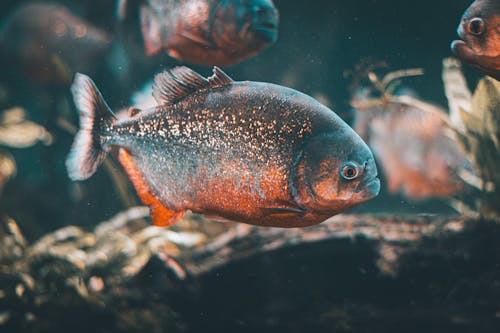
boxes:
[211,0,279,54]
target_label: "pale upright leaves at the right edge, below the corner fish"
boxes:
[443,58,500,217]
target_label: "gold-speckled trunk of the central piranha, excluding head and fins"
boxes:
[101,82,364,226]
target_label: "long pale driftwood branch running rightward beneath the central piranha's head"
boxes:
[177,214,467,277]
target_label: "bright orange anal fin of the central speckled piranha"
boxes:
[118,148,186,227]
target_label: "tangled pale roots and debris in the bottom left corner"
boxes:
[0,207,205,330]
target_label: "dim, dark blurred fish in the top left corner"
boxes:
[0,3,111,84]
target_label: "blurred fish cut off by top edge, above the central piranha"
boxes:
[118,0,279,66]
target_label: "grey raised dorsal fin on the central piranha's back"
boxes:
[153,66,233,104]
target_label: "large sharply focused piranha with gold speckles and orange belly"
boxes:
[67,67,380,227]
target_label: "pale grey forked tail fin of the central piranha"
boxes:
[66,73,115,180]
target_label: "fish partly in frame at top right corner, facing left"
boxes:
[451,0,500,80]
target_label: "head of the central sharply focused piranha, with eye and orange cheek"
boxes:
[291,131,380,215]
